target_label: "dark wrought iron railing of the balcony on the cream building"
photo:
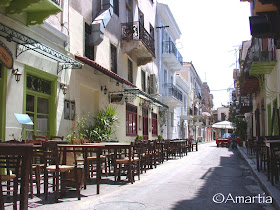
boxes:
[121,21,155,55]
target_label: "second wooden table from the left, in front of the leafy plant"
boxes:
[57,144,104,194]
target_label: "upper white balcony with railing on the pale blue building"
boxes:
[162,41,183,71]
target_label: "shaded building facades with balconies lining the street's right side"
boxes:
[235,0,280,139]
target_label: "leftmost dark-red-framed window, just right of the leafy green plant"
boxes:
[126,104,137,136]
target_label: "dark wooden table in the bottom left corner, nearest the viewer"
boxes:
[0,143,33,210]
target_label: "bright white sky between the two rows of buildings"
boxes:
[158,0,251,108]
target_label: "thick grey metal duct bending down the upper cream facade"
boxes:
[89,0,113,46]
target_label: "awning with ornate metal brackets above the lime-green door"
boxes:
[0,23,82,73]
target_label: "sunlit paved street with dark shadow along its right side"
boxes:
[31,142,274,210]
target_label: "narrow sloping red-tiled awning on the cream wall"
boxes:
[75,55,136,88]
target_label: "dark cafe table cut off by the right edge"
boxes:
[264,140,280,185]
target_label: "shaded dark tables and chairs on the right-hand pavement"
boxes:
[246,136,280,185]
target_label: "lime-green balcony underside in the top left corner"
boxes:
[0,0,62,25]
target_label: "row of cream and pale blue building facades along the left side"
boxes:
[0,0,214,141]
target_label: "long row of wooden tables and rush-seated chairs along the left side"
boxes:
[0,136,198,209]
